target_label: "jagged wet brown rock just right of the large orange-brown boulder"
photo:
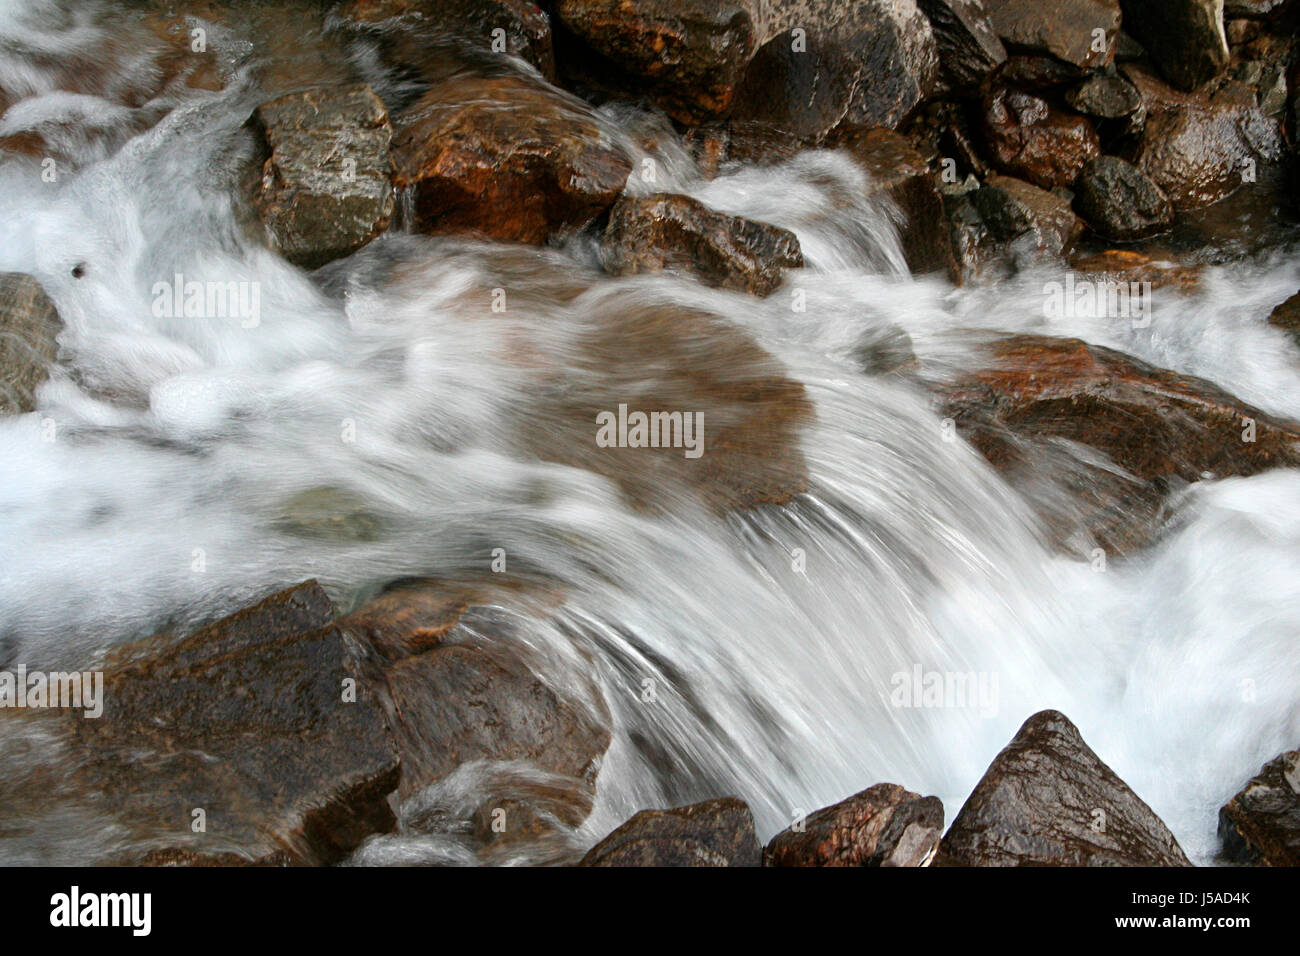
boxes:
[601,194,803,295]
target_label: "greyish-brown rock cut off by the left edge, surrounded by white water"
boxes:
[0,272,62,415]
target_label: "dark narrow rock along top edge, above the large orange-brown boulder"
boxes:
[339,0,555,79]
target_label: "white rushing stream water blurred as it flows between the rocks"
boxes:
[0,3,1300,862]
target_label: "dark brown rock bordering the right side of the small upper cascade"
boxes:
[835,129,961,282]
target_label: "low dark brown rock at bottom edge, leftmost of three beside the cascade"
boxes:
[579,797,762,866]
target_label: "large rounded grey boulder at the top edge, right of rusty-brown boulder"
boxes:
[733,0,939,144]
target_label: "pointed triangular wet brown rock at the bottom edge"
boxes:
[936,710,1191,866]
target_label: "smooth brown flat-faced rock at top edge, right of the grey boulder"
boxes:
[984,0,1119,69]
